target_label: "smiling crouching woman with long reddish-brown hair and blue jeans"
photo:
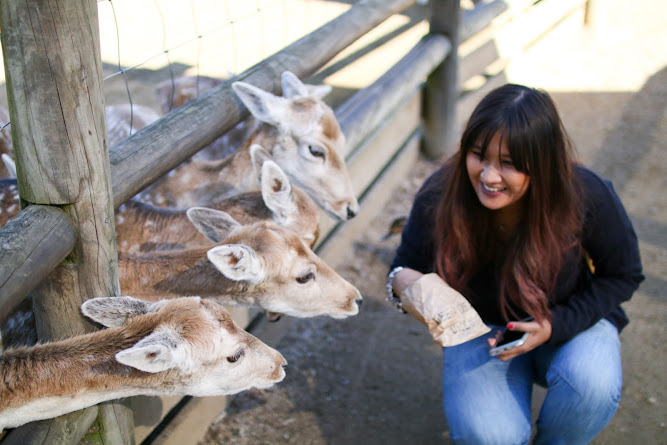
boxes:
[387,84,643,444]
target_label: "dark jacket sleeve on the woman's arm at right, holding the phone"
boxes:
[549,168,644,344]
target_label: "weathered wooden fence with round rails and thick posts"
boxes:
[0,0,591,445]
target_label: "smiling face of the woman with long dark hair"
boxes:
[466,132,530,210]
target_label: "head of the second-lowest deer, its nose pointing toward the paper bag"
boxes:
[187,207,362,318]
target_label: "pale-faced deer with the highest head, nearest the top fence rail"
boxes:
[142,71,359,221]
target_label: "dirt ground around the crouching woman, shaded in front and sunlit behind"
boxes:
[196,0,667,445]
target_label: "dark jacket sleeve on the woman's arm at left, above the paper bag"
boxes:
[389,169,442,273]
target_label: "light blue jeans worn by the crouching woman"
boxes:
[442,319,623,445]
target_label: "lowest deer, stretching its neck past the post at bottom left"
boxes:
[0,296,287,431]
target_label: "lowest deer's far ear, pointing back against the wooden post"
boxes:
[81,297,167,328]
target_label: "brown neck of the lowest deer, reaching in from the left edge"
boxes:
[0,325,177,430]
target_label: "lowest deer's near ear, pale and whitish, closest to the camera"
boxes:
[116,329,194,373]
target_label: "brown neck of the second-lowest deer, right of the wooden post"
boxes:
[118,245,261,306]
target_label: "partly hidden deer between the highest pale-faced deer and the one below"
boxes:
[116,145,320,253]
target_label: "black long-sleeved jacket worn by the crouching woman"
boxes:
[391,166,644,344]
